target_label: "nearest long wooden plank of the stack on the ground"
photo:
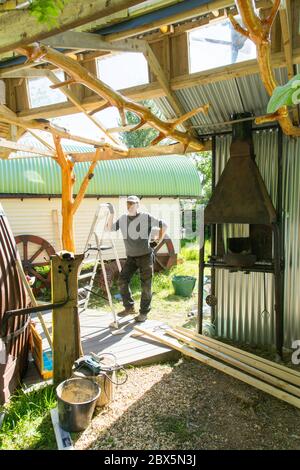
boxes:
[135,327,300,408]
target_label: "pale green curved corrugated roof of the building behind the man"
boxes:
[0,156,201,197]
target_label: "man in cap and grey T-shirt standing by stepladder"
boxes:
[106,196,167,322]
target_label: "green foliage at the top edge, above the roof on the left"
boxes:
[29,0,70,27]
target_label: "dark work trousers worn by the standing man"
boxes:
[119,253,154,314]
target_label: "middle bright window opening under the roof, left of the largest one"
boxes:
[97,52,149,90]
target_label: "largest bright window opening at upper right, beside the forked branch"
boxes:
[189,17,256,73]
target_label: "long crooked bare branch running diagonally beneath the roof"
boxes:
[18,44,207,151]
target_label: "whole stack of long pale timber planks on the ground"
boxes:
[135,326,300,408]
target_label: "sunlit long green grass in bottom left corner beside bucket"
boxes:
[0,386,57,450]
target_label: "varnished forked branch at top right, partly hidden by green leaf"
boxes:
[228,0,300,136]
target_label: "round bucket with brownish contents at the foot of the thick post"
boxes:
[56,378,101,432]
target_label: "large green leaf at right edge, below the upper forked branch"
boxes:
[267,74,300,113]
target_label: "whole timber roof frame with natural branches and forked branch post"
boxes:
[0,0,300,251]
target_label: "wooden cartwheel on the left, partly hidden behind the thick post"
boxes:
[15,235,55,293]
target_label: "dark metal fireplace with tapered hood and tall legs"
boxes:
[198,114,283,355]
